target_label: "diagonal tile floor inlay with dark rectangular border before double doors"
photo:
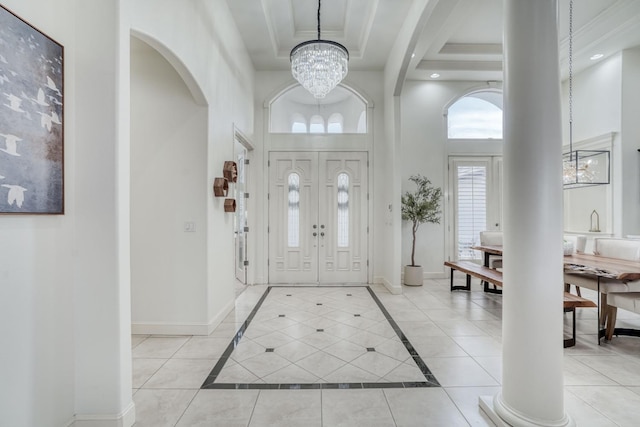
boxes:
[201,286,440,389]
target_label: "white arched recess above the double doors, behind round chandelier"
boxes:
[264,82,373,133]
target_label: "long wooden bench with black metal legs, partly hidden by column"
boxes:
[444,261,597,348]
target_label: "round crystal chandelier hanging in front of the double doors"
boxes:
[290,0,349,98]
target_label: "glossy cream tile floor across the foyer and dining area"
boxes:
[132,279,640,427]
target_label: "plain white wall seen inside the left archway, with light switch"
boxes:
[131,38,209,334]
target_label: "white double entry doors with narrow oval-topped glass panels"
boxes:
[268,152,368,283]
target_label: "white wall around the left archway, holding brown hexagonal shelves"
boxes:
[130,0,254,329]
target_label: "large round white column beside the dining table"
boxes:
[480,0,574,426]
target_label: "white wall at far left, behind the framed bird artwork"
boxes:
[0,0,131,426]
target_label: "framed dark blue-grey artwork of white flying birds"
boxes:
[0,5,64,214]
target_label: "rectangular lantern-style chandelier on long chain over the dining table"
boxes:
[562,0,610,189]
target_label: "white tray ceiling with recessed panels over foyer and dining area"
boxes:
[227,0,640,81]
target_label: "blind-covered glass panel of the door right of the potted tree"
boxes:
[456,166,487,259]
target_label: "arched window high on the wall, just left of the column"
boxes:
[447,90,502,139]
